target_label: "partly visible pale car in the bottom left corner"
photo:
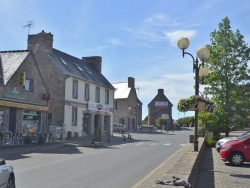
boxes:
[0,159,16,188]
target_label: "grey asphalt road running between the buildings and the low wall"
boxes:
[7,128,193,188]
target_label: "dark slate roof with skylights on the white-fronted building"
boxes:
[49,49,114,89]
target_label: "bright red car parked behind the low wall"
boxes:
[220,136,250,166]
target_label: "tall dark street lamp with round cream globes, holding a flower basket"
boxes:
[177,37,210,151]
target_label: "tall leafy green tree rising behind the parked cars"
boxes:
[206,17,250,136]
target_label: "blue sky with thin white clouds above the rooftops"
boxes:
[0,0,250,120]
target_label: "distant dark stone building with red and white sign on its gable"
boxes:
[148,89,173,126]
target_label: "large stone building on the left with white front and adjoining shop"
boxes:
[0,31,114,136]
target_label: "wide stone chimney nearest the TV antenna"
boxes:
[27,30,53,53]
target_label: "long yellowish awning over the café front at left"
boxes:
[0,99,49,111]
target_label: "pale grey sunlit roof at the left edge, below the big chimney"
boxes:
[0,50,30,85]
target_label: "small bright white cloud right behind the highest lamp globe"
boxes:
[163,30,197,46]
